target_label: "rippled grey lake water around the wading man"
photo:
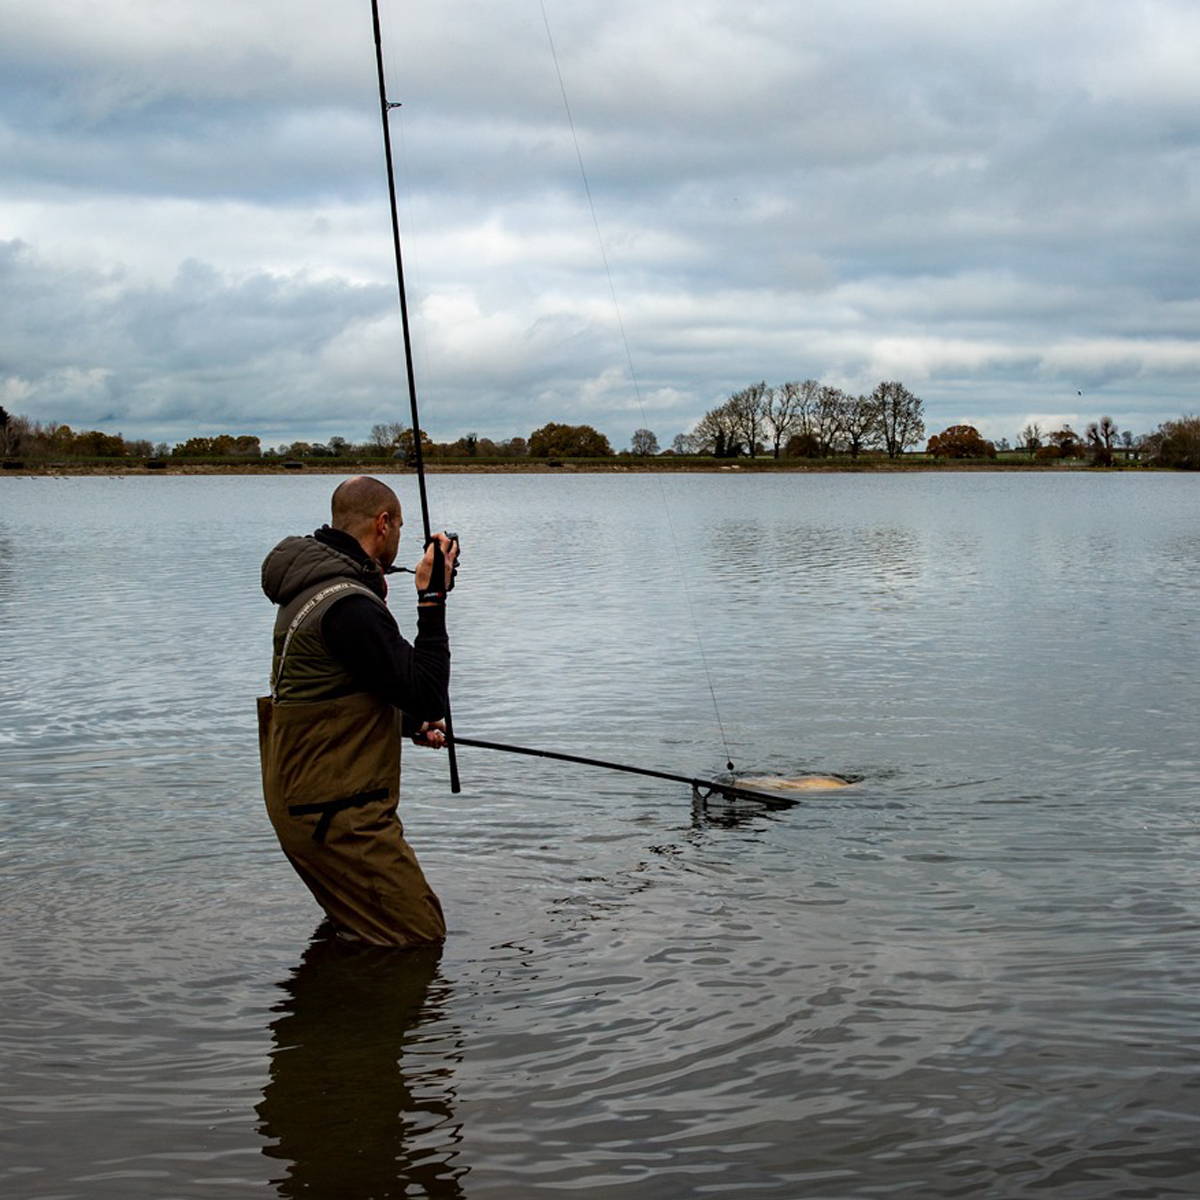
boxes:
[0,472,1200,1200]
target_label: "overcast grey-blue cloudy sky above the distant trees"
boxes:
[0,0,1200,448]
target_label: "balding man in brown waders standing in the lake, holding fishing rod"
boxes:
[258,475,458,946]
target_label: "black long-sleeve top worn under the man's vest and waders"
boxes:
[314,526,450,734]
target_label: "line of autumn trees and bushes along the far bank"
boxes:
[0,398,1200,470]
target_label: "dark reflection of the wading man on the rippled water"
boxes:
[258,937,467,1200]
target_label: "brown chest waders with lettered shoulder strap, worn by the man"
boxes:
[258,581,445,946]
